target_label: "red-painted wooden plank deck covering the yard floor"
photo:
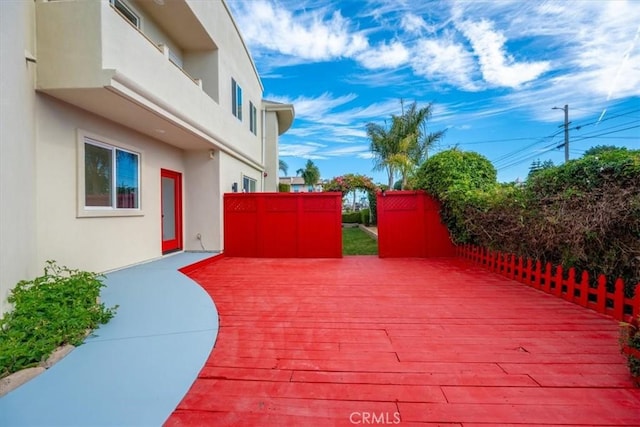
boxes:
[166,257,640,426]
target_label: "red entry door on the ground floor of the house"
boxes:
[160,169,182,254]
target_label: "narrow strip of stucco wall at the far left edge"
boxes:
[0,1,39,317]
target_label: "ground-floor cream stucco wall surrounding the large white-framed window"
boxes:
[36,95,185,271]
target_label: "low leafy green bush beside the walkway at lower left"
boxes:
[0,261,117,377]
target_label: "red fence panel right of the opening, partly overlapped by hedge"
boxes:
[377,191,455,258]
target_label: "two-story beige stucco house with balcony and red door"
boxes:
[0,0,294,315]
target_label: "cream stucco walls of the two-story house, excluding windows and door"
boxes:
[0,0,290,314]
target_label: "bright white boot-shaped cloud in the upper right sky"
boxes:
[458,20,550,88]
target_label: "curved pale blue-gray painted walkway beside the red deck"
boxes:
[0,253,218,427]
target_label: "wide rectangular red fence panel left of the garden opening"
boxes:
[224,193,342,258]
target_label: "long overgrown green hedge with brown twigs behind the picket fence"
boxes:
[418,149,640,296]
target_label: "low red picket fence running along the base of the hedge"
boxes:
[457,245,640,322]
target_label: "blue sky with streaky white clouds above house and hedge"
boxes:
[228,0,640,183]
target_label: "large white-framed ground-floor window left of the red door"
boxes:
[83,137,140,210]
